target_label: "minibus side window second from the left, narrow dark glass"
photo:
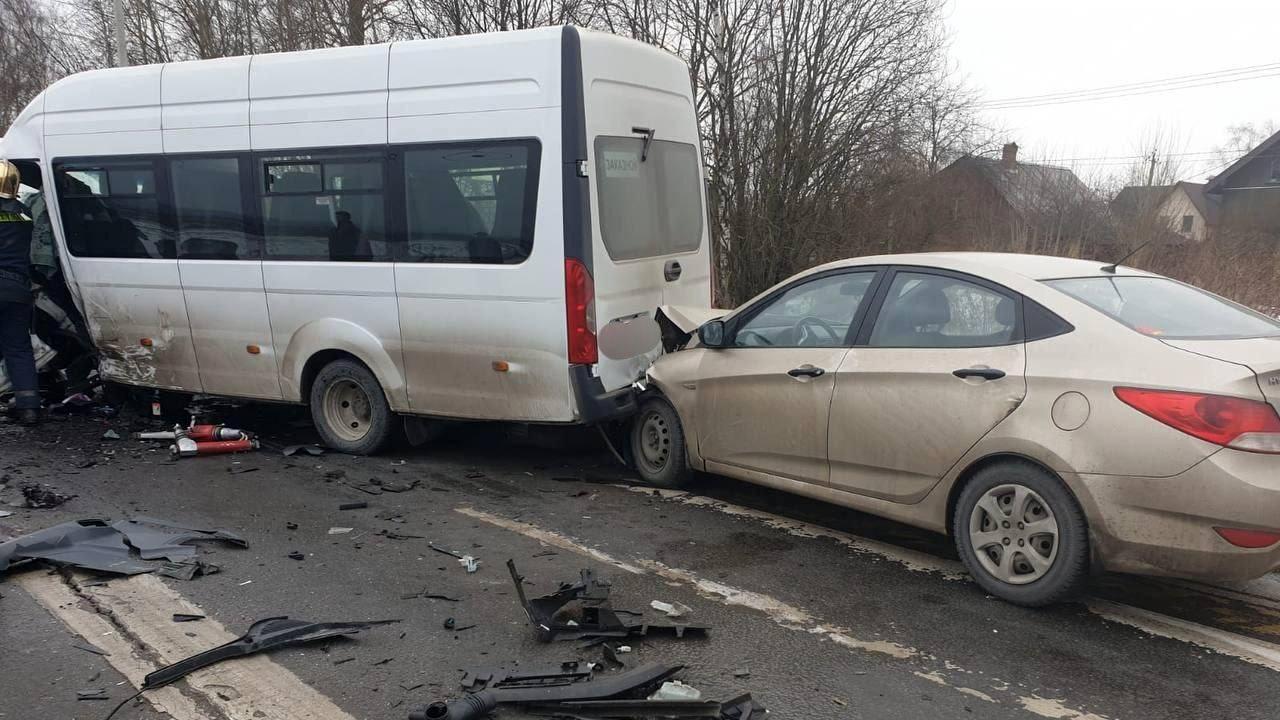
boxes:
[169,156,259,260]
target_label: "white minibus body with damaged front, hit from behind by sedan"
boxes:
[5,27,710,440]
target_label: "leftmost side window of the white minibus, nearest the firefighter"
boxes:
[54,159,177,260]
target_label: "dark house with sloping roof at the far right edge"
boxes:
[1204,132,1280,232]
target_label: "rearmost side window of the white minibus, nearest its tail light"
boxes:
[404,141,540,265]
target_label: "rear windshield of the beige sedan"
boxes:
[1044,275,1280,340]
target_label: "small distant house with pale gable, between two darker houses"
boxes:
[1111,182,1220,243]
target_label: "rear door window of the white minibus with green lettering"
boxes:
[595,136,703,260]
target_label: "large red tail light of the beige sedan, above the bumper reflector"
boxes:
[1115,387,1280,454]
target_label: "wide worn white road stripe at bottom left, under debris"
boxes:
[14,573,355,720]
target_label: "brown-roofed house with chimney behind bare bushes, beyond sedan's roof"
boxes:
[892,142,1098,255]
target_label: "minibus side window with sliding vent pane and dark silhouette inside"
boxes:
[259,151,392,261]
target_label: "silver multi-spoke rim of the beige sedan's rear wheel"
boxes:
[969,483,1060,585]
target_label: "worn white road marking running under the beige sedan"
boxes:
[634,486,1280,671]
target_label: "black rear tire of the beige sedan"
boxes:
[951,460,1089,607]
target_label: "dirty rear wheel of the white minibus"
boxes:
[311,359,397,455]
